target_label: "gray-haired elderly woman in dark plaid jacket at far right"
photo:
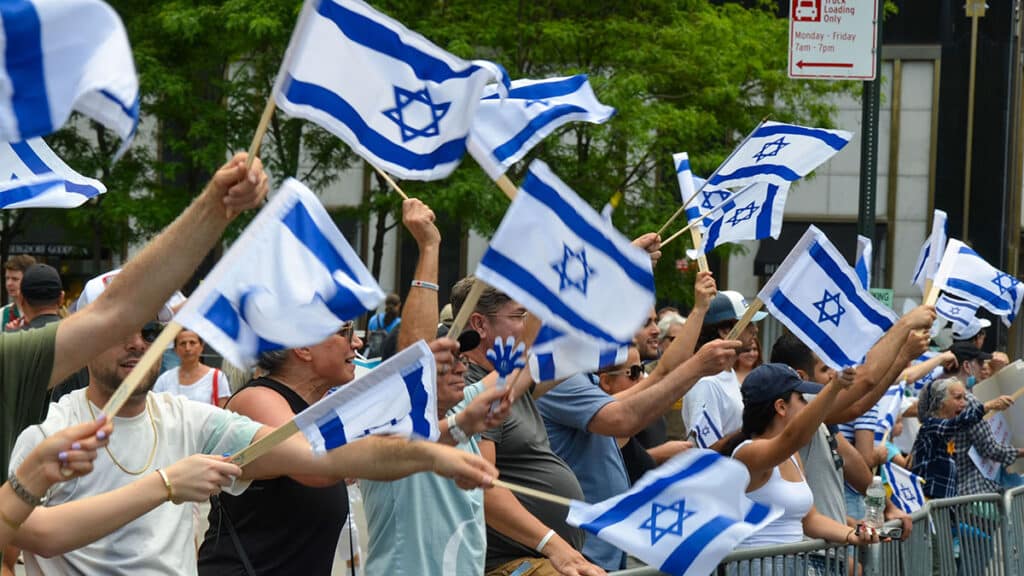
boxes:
[911,378,1020,498]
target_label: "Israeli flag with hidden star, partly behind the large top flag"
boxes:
[467,74,615,180]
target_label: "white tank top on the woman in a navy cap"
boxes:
[732,440,814,548]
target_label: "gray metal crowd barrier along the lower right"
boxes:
[611,487,1024,576]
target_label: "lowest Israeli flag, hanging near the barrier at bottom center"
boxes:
[566,448,782,576]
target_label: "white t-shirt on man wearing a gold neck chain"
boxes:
[10,388,260,576]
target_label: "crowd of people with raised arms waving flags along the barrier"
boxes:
[0,155,1024,576]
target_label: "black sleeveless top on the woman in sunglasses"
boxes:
[199,378,348,576]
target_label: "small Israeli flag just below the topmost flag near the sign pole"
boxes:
[701,182,790,254]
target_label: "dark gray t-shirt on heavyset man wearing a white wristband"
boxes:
[464,364,584,571]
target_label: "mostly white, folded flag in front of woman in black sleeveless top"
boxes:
[295,340,440,454]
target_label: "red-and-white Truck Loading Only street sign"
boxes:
[790,0,879,80]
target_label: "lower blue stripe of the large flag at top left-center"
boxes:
[285,76,466,170]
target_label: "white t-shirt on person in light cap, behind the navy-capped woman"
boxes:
[683,369,743,438]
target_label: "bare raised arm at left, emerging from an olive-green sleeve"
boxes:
[49,153,267,387]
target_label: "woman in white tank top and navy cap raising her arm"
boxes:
[732,364,878,547]
